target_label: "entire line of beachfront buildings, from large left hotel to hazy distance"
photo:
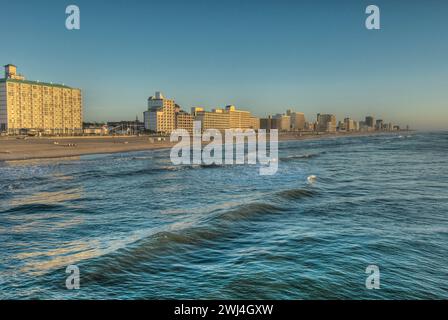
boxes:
[0,64,406,135]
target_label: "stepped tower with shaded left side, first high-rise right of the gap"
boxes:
[143,92,176,134]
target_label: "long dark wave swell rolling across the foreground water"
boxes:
[67,203,285,282]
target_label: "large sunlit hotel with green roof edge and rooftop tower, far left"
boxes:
[0,64,82,135]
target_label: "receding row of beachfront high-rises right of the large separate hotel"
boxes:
[144,92,400,134]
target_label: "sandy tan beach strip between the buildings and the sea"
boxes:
[0,131,406,162]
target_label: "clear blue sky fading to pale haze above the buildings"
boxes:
[0,0,448,129]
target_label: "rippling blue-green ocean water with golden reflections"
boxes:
[0,132,448,299]
